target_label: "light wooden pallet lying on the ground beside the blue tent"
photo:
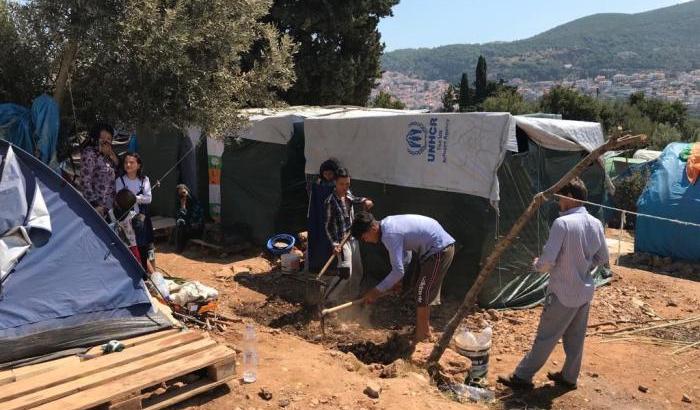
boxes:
[0,330,235,410]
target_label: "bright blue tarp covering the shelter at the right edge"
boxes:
[635,142,700,261]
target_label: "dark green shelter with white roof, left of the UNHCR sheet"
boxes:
[220,107,426,244]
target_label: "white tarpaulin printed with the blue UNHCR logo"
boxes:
[304,113,515,201]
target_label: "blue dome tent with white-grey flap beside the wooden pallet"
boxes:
[0,141,170,364]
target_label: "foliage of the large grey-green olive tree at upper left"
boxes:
[4,0,294,135]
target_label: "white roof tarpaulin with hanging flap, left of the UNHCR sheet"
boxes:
[239,106,426,144]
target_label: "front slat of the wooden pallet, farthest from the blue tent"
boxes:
[32,345,235,410]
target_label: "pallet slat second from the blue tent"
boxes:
[0,332,205,403]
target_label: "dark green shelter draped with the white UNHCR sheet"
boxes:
[304,113,605,307]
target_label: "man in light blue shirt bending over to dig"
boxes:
[352,212,455,343]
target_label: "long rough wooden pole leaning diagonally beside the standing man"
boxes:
[427,135,646,377]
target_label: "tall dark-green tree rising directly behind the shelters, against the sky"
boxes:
[268,0,399,105]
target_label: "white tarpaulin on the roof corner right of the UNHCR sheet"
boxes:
[508,115,605,152]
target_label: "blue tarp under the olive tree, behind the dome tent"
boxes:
[0,94,60,164]
